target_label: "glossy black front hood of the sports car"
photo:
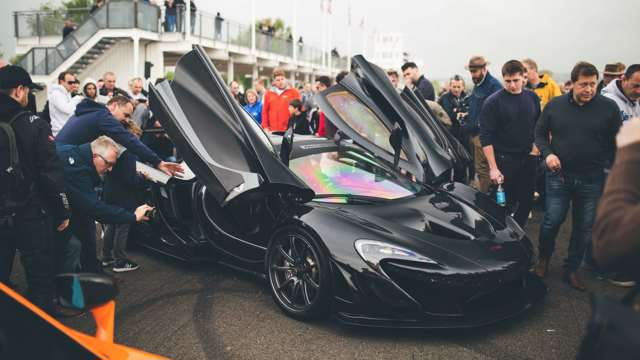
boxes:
[324,191,531,270]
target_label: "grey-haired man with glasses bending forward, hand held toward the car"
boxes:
[55,136,153,272]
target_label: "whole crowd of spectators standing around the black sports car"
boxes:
[0,48,640,318]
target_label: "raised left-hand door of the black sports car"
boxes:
[150,46,314,206]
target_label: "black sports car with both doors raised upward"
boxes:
[139,47,546,327]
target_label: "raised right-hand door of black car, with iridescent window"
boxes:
[315,55,454,182]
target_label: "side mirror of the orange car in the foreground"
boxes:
[55,273,118,311]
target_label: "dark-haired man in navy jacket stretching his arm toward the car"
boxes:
[56,95,182,176]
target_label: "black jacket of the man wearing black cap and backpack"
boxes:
[0,93,69,224]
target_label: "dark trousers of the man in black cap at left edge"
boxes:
[0,215,53,311]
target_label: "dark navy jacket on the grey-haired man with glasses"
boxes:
[57,144,136,224]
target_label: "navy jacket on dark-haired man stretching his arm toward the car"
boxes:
[56,99,161,166]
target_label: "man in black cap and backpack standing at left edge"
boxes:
[0,65,70,311]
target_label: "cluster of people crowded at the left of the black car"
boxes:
[0,65,183,311]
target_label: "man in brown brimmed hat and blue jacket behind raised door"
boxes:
[464,56,502,193]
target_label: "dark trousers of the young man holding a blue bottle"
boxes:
[492,153,536,228]
